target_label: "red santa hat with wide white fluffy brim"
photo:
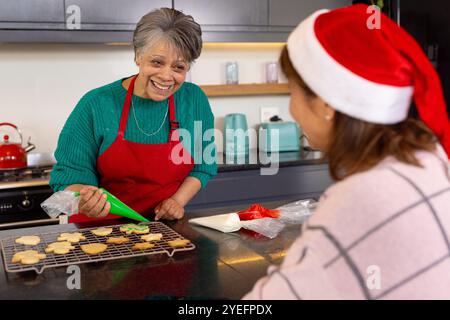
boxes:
[287,5,450,157]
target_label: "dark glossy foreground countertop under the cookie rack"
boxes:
[0,201,300,299]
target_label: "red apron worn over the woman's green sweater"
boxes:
[69,76,194,223]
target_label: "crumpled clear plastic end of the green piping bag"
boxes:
[41,191,80,219]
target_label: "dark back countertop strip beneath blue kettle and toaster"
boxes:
[217,149,327,172]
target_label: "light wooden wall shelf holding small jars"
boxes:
[200,83,290,97]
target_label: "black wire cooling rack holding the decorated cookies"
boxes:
[0,222,195,274]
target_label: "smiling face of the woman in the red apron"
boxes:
[135,40,189,101]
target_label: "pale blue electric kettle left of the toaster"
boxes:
[223,113,249,156]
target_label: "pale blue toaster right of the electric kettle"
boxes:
[259,116,300,152]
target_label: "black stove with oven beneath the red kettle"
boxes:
[0,153,60,229]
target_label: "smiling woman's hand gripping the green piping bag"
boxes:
[78,186,111,218]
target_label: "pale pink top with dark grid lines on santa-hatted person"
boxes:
[244,146,450,299]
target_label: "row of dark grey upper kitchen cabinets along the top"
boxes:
[0,0,351,44]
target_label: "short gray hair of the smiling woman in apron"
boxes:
[133,8,203,63]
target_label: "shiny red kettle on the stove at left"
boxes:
[0,122,35,170]
